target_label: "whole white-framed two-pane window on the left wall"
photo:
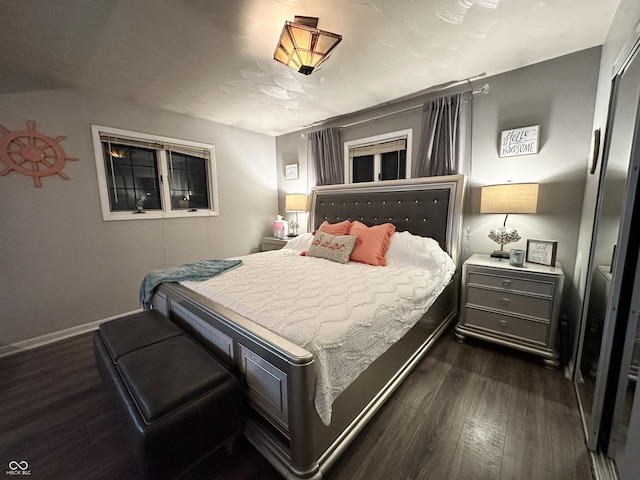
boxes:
[91,125,218,220]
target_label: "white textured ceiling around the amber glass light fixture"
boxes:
[0,0,619,135]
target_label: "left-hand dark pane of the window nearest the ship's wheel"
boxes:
[102,142,162,212]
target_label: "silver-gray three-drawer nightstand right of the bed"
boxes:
[456,254,564,368]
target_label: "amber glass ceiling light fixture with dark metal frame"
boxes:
[273,15,342,75]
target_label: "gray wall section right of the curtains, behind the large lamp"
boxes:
[469,48,600,338]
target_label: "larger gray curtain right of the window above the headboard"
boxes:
[413,91,473,177]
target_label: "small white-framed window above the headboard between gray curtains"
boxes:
[344,129,412,183]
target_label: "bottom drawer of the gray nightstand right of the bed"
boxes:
[465,308,549,345]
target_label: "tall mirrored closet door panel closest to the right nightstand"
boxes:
[574,36,640,451]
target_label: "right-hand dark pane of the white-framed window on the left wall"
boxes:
[168,152,209,210]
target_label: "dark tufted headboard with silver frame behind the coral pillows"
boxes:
[311,175,465,264]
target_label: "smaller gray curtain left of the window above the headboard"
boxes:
[309,127,344,185]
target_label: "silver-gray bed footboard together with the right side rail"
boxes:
[153,276,458,479]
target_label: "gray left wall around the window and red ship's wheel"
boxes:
[0,89,277,346]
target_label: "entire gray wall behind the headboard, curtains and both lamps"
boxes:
[276,47,600,342]
